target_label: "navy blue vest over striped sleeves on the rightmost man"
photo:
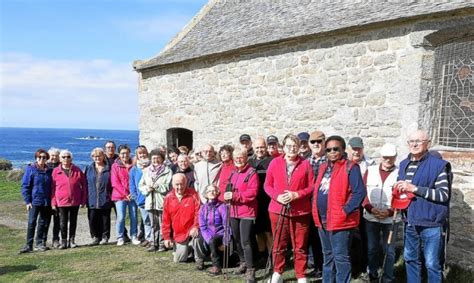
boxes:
[398,153,449,227]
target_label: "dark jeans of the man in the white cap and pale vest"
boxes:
[364,220,398,282]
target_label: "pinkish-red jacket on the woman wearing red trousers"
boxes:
[264,155,313,216]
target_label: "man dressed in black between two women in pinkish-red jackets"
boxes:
[249,138,273,266]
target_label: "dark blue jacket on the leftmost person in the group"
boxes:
[21,163,53,206]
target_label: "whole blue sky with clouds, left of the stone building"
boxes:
[0,0,207,129]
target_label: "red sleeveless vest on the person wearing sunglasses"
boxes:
[313,159,360,231]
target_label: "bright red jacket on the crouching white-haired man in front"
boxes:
[161,188,201,243]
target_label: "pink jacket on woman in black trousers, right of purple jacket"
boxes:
[230,163,258,218]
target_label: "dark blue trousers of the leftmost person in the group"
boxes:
[26,205,52,248]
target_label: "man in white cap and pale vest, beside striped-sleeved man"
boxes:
[363,143,401,282]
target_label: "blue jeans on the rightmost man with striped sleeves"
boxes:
[404,224,443,283]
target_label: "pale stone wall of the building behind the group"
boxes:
[139,14,474,268]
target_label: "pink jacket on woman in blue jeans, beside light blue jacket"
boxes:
[110,158,133,201]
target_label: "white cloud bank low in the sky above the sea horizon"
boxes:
[0,53,138,129]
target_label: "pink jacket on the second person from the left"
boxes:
[51,165,87,207]
